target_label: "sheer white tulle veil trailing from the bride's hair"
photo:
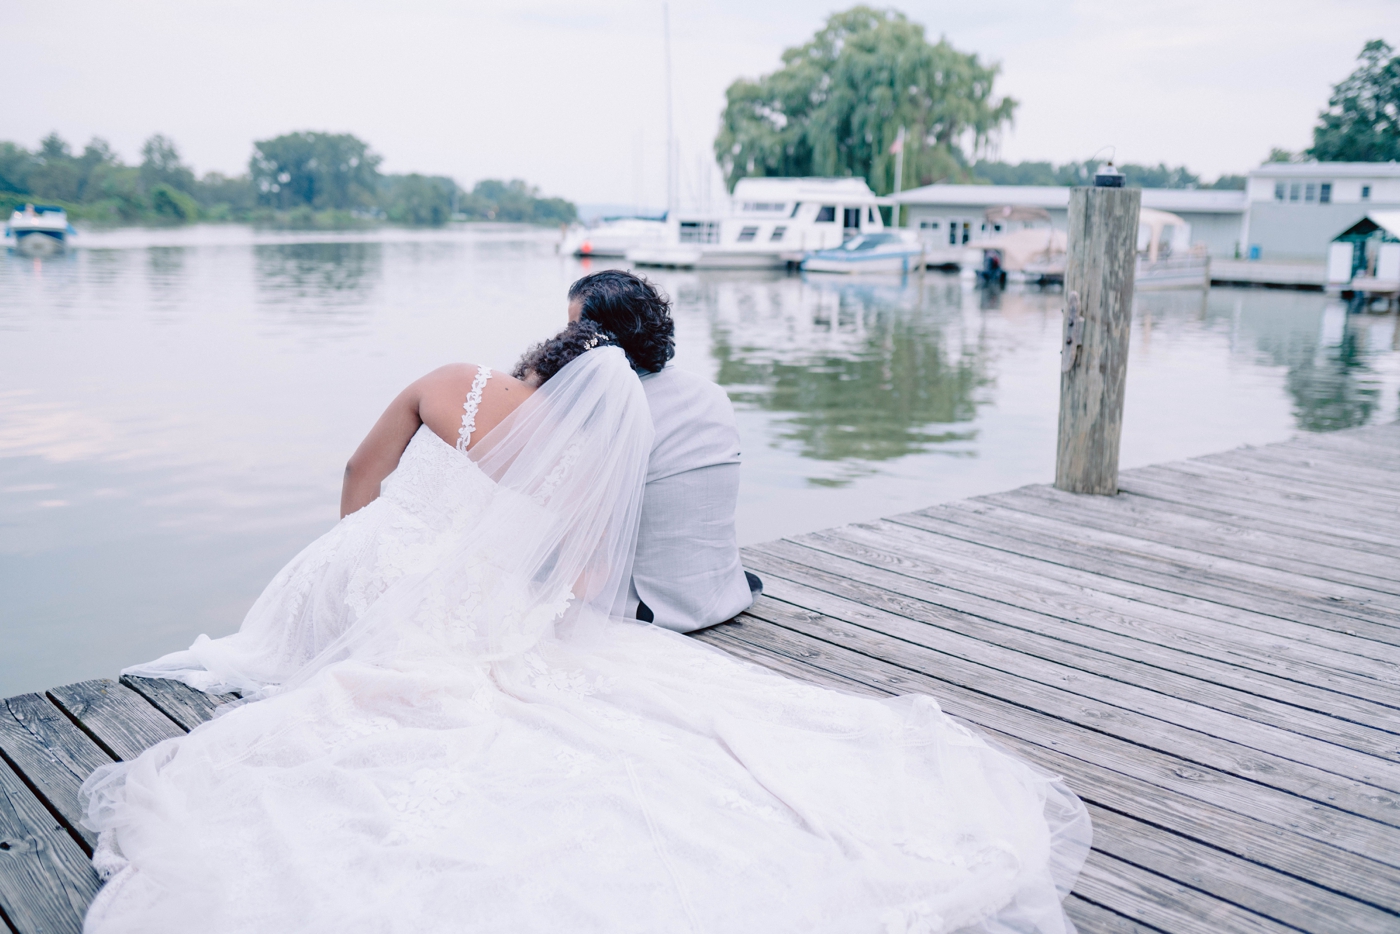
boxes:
[273,346,652,692]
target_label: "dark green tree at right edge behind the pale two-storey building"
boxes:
[1308,39,1400,162]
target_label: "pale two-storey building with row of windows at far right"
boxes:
[1243,162,1400,262]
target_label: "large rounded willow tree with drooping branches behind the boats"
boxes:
[714,7,1016,193]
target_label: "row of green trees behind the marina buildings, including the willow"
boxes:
[714,6,1400,195]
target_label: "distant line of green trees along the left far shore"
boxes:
[0,132,577,227]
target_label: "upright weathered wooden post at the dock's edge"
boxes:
[1054,188,1142,496]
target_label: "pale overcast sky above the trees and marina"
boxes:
[0,0,1400,204]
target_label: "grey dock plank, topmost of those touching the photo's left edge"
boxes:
[0,695,112,853]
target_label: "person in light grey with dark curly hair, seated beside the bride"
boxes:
[568,269,763,633]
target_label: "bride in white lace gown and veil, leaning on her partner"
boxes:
[84,280,1089,934]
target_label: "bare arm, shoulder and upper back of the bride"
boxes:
[340,363,535,518]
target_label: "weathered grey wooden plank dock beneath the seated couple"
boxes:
[0,426,1400,934]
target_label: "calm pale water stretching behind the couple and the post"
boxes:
[0,227,1400,696]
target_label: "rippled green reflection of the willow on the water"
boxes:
[691,279,993,486]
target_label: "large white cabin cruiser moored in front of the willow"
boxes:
[627,178,885,269]
